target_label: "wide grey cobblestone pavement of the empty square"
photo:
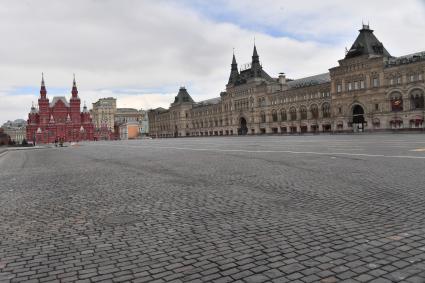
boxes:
[0,134,425,283]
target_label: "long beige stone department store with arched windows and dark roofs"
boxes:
[149,25,425,137]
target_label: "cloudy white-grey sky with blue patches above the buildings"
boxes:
[0,0,425,124]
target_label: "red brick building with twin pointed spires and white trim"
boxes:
[27,77,94,143]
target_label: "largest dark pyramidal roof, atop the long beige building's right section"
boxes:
[345,24,391,59]
